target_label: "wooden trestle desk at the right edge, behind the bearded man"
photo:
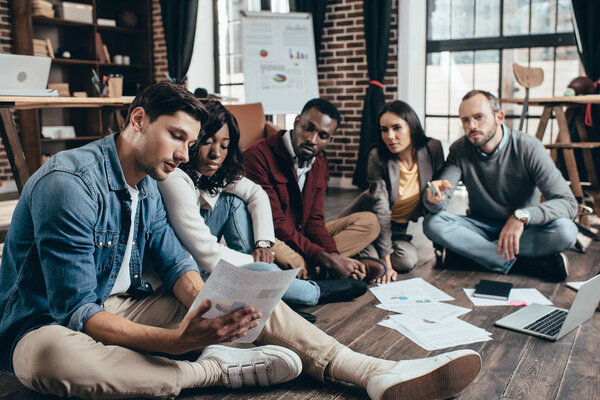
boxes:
[500,95,600,216]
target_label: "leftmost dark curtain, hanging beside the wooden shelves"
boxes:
[160,0,198,83]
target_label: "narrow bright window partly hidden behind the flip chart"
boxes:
[214,0,290,103]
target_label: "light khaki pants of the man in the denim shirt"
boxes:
[13,294,344,399]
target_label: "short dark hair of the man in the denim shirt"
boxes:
[126,82,208,125]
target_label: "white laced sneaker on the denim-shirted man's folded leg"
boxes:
[198,345,302,389]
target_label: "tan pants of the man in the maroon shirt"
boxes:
[272,211,380,279]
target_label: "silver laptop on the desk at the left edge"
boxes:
[0,54,57,96]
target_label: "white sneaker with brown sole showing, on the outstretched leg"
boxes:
[367,350,481,400]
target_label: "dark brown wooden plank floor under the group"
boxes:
[0,192,600,400]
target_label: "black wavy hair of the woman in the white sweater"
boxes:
[179,100,244,196]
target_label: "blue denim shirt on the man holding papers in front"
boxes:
[0,134,198,371]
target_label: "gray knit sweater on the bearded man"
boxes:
[423,128,577,225]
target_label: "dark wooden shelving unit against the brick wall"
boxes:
[11,0,154,173]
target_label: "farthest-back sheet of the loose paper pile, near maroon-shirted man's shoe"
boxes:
[370,278,454,304]
